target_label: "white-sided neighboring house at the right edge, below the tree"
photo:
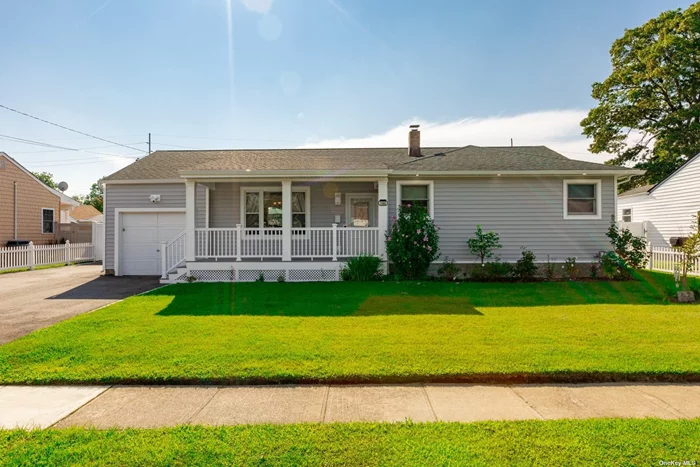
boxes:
[617,154,700,247]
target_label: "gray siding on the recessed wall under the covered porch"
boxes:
[209,182,377,228]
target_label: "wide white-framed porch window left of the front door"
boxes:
[242,187,310,229]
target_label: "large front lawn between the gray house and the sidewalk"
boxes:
[0,274,700,384]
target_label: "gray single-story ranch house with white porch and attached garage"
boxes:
[104,124,643,280]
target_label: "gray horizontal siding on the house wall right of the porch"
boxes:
[389,177,615,262]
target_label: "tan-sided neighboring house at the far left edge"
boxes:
[0,152,78,247]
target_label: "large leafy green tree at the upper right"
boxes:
[581,3,700,189]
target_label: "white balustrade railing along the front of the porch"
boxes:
[195,226,383,260]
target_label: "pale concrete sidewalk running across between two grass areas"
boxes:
[0,384,700,428]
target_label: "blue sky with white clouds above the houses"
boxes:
[0,0,689,193]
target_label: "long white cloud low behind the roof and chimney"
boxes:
[302,109,610,162]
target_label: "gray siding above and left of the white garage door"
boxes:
[104,183,185,269]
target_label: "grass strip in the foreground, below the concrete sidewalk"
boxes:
[0,419,700,466]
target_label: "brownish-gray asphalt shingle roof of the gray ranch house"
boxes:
[106,146,636,180]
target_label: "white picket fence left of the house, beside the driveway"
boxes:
[0,242,95,271]
